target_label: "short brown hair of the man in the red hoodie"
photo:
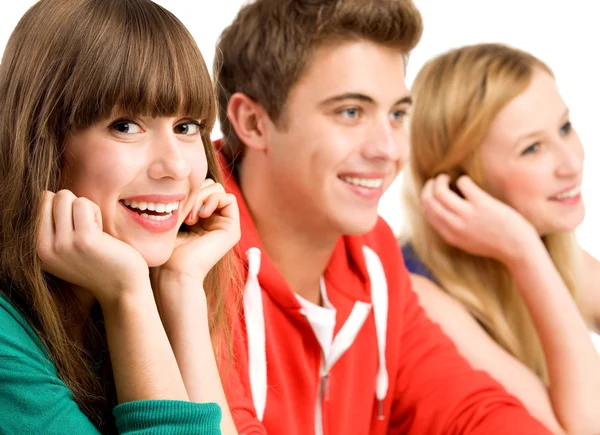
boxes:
[214,0,423,161]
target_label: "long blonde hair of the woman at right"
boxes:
[403,44,579,383]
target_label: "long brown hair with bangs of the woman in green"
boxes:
[0,0,230,431]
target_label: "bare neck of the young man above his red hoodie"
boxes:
[238,157,339,305]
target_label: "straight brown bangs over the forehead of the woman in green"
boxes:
[63,0,216,133]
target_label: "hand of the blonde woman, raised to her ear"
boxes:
[421,174,540,265]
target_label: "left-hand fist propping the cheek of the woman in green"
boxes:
[36,190,148,304]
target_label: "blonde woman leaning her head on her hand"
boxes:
[403,44,600,434]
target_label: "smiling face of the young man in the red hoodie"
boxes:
[258,41,411,235]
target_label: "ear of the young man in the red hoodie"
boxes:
[227,92,270,151]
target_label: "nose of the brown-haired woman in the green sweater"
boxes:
[148,130,191,180]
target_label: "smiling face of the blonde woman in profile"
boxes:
[481,69,585,235]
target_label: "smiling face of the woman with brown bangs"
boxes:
[64,112,208,267]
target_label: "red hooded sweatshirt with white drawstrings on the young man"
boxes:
[221,151,550,435]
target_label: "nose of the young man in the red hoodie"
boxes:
[364,116,409,164]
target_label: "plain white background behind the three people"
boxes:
[0,0,600,258]
